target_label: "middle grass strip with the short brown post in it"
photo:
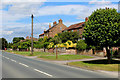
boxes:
[39,55,93,61]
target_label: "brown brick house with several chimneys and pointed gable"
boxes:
[39,19,67,38]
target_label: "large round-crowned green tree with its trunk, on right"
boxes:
[83,8,120,63]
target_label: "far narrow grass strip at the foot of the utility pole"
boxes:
[6,50,54,56]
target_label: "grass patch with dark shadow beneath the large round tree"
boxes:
[68,59,120,71]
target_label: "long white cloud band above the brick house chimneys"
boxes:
[37,5,87,16]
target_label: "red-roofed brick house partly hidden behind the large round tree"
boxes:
[63,17,88,38]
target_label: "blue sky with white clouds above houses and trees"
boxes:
[0,0,119,42]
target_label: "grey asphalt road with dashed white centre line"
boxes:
[0,52,117,78]
